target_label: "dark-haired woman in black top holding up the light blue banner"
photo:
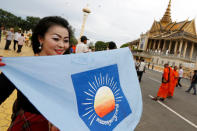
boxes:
[0,16,72,131]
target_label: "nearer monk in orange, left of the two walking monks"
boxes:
[152,64,170,101]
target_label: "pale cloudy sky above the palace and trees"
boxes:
[0,0,197,47]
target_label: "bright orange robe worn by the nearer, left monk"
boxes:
[157,67,169,99]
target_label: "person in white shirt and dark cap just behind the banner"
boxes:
[76,36,89,53]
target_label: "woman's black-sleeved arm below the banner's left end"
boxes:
[0,73,15,105]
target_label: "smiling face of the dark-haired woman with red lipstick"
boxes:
[38,25,69,56]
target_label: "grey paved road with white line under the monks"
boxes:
[135,70,197,131]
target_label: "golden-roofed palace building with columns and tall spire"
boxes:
[131,0,197,68]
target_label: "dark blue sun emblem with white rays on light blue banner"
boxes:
[71,65,132,131]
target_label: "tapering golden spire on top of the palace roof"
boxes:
[160,0,172,24]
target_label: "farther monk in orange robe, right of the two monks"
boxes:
[168,66,179,98]
